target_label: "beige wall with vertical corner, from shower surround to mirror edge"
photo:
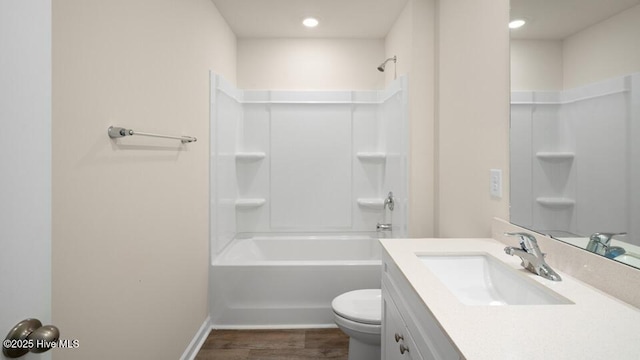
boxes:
[385,0,509,237]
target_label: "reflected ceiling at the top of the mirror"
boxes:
[511,0,640,39]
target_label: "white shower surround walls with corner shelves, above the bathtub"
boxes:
[210,73,407,255]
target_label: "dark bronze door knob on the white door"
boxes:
[2,319,60,359]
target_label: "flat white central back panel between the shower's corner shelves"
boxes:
[270,104,352,230]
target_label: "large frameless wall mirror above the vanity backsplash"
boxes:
[510,0,640,268]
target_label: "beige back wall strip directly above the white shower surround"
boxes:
[238,39,384,90]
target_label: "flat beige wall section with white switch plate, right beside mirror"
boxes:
[436,0,509,237]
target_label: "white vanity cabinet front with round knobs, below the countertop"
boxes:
[382,252,463,360]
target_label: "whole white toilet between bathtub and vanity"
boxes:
[331,289,382,360]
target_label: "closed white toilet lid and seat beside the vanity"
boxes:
[331,289,382,325]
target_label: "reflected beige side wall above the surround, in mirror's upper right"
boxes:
[563,5,640,89]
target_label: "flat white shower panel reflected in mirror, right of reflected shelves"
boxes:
[562,78,631,234]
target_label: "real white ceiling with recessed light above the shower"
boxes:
[212,0,408,38]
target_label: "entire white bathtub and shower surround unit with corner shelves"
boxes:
[210,74,407,327]
